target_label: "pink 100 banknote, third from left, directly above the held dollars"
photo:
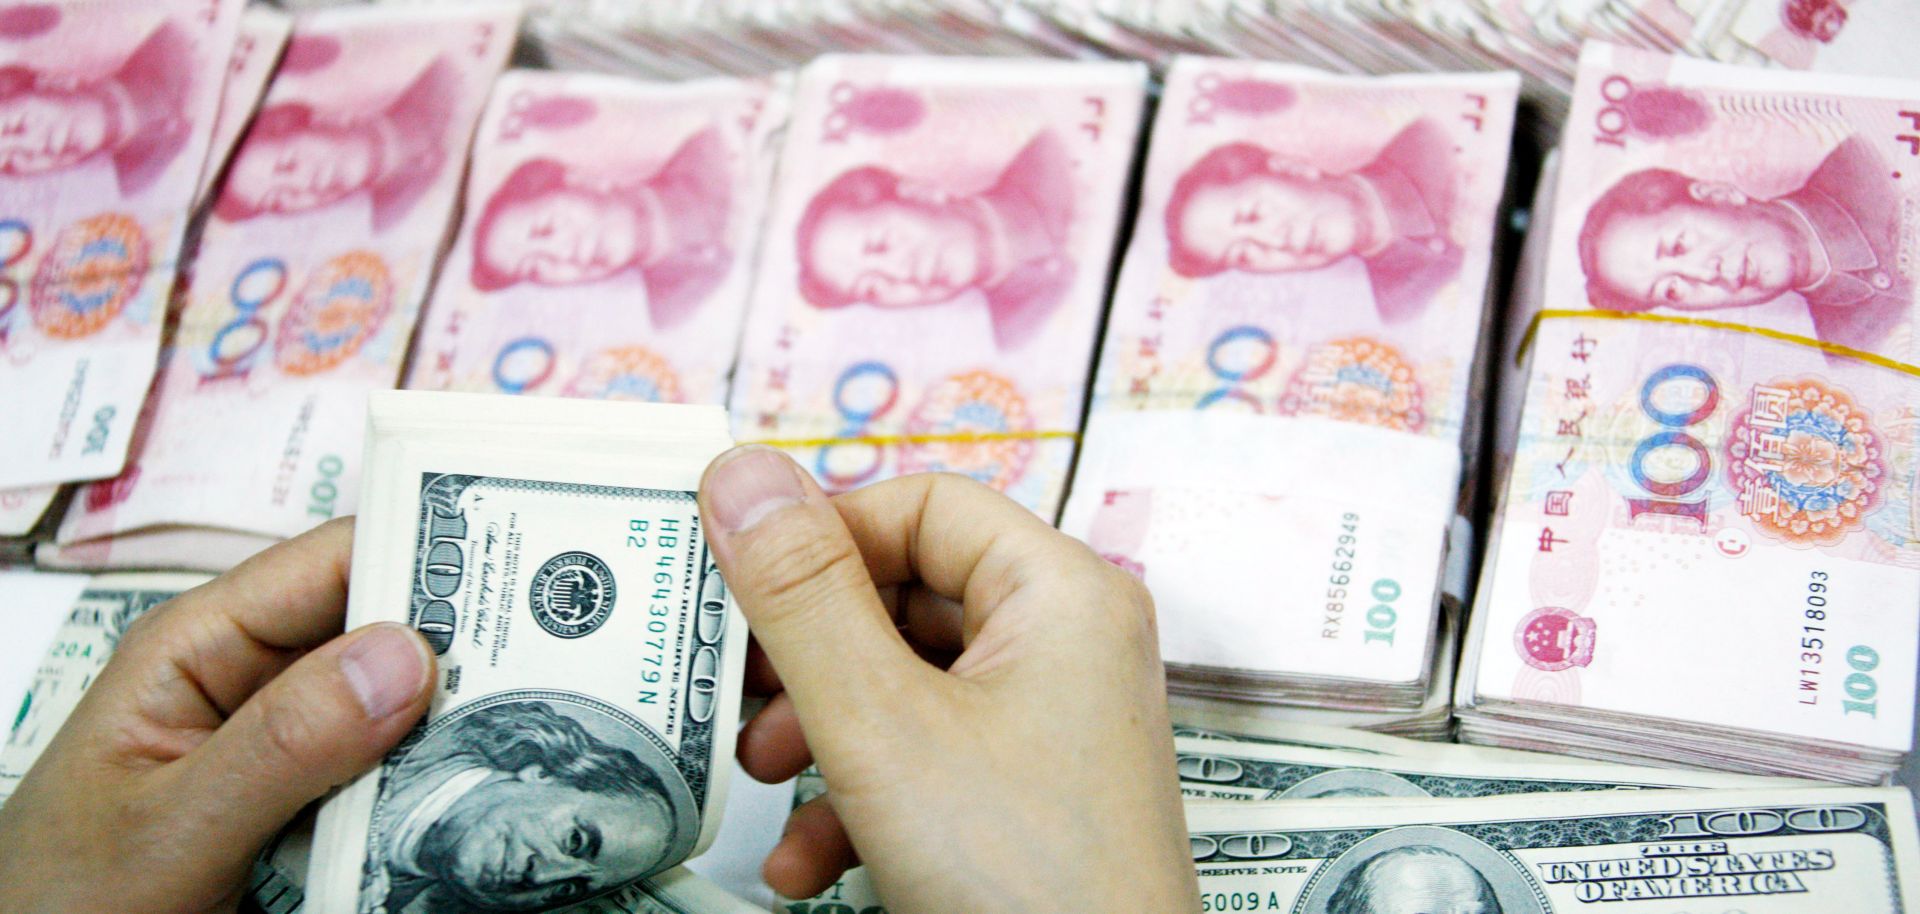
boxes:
[407,71,787,403]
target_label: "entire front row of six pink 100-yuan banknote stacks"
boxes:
[0,0,1920,794]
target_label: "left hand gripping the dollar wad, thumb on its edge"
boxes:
[0,520,434,914]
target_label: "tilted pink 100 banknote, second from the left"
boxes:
[60,4,518,543]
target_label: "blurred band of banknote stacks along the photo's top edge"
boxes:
[518,0,1920,113]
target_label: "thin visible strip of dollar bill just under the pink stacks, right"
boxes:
[1173,735,1814,801]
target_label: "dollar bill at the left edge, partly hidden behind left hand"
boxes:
[0,574,209,803]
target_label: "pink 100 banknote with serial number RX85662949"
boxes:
[1062,58,1519,683]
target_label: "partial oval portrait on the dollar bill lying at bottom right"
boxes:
[1304,826,1546,914]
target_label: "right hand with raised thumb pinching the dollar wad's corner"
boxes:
[701,447,1200,914]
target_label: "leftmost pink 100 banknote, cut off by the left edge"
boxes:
[0,0,240,490]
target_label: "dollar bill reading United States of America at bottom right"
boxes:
[1187,787,1920,914]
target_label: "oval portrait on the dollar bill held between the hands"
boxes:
[363,693,699,914]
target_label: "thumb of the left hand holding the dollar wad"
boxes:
[161,622,434,860]
